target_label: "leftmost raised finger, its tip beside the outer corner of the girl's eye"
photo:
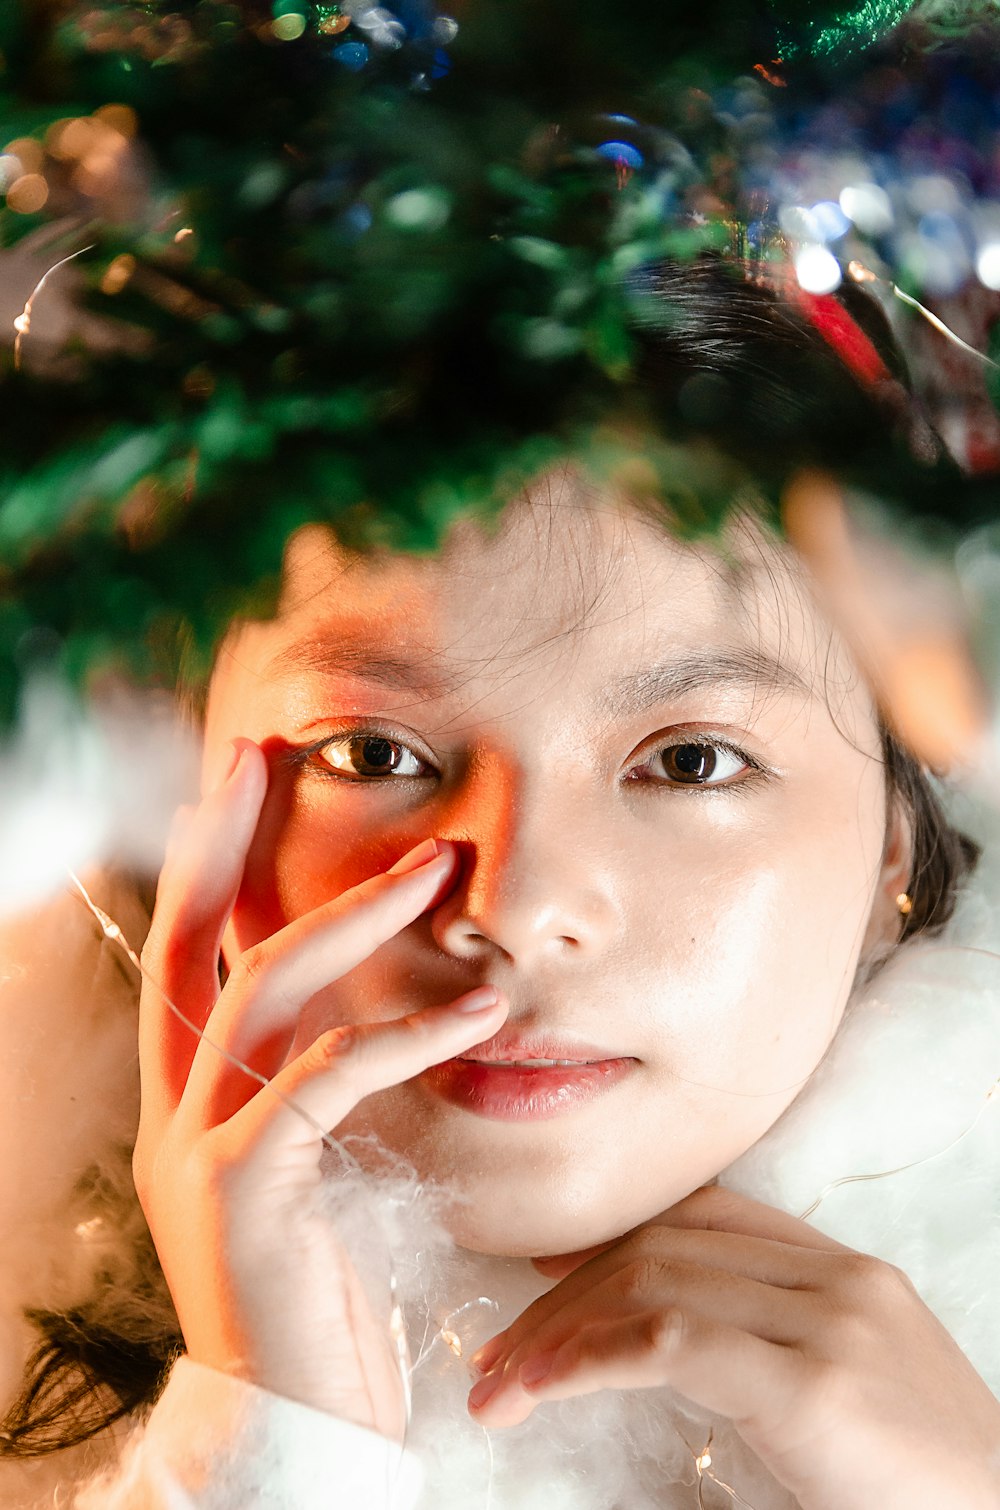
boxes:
[139,741,267,1125]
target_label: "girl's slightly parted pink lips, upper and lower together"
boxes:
[417,1031,637,1122]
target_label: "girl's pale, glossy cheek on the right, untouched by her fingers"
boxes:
[633,776,882,1105]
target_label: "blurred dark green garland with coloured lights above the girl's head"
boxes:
[0,0,996,717]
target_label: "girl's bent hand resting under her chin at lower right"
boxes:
[470,1187,1000,1510]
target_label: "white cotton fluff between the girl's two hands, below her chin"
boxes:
[309,1143,779,1510]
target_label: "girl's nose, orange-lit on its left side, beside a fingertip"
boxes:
[431,766,621,969]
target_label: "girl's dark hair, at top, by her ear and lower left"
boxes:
[0,257,980,1457]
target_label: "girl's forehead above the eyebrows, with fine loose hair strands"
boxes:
[273,498,831,682]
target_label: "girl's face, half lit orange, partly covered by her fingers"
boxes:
[205,494,906,1255]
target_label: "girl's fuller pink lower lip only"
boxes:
[417,1059,637,1122]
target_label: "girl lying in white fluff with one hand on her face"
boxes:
[6,253,1000,1510]
